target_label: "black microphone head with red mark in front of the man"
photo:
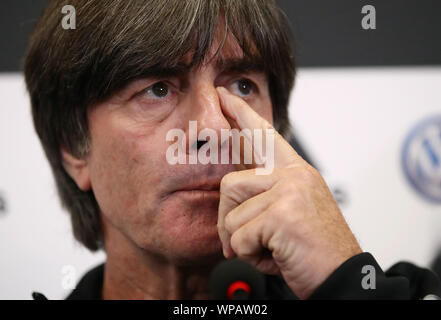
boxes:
[210,259,265,300]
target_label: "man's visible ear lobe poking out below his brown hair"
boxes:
[61,148,92,191]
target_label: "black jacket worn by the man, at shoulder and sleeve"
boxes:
[42,252,441,300]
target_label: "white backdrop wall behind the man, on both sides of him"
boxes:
[0,67,441,299]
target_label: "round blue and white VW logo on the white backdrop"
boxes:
[401,116,441,203]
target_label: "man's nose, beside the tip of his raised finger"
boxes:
[183,79,231,152]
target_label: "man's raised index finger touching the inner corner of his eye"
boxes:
[216,87,301,168]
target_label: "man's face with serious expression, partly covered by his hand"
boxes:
[87,35,272,264]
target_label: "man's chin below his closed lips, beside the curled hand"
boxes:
[135,192,223,266]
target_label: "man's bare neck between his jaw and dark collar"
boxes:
[102,219,222,300]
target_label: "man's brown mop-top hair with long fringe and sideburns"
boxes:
[24,0,295,250]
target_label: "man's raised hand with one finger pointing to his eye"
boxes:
[217,87,362,299]
